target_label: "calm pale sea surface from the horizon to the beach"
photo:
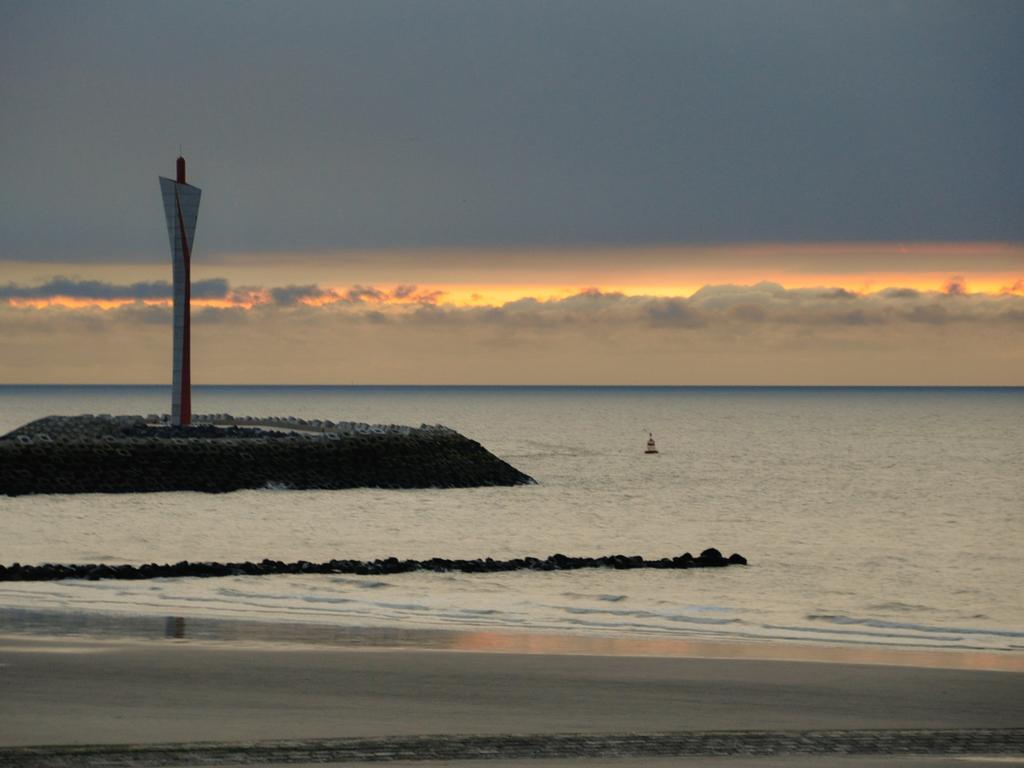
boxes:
[0,386,1024,651]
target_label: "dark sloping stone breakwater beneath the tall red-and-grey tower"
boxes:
[0,414,534,496]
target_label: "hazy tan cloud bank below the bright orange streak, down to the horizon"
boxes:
[0,283,1024,393]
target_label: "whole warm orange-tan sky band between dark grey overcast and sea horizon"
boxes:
[0,243,1024,384]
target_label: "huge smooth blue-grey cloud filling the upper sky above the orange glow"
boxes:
[0,0,1024,260]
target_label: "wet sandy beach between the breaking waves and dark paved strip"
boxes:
[0,612,1024,746]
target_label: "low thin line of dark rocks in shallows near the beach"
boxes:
[0,547,746,582]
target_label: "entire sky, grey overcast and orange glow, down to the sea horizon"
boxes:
[0,0,1024,385]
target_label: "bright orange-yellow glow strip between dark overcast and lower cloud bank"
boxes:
[0,243,1024,309]
